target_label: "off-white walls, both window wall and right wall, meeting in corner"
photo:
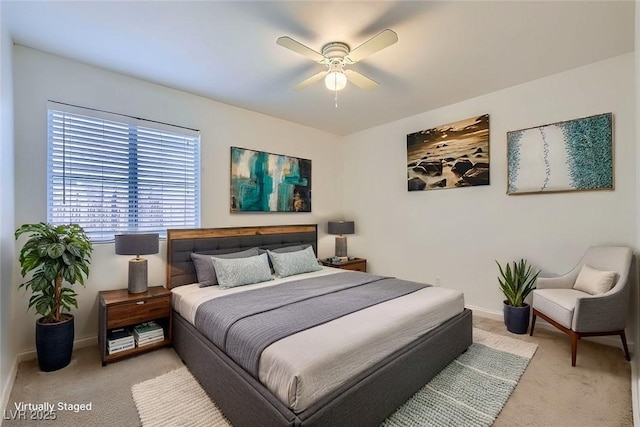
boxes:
[6,46,640,408]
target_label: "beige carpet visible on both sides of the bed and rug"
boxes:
[2,313,636,427]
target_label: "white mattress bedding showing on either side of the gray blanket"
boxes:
[172,267,464,412]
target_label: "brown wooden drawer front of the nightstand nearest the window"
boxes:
[107,296,171,329]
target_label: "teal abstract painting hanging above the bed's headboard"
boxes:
[231,147,311,212]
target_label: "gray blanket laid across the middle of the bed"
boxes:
[195,272,429,378]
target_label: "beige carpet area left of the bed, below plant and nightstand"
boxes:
[2,345,184,427]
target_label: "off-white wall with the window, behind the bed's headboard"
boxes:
[14,46,342,351]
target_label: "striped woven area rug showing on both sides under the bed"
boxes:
[131,328,538,427]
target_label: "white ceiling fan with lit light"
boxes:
[276,29,398,92]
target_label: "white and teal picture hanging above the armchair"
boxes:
[507,113,613,194]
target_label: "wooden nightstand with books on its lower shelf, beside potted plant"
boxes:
[98,286,171,366]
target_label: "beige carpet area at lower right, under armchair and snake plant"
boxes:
[473,316,638,427]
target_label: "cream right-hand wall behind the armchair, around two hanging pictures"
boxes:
[343,54,637,314]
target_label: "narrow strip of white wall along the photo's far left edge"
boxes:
[0,5,17,408]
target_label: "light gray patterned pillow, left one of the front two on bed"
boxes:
[211,254,272,289]
